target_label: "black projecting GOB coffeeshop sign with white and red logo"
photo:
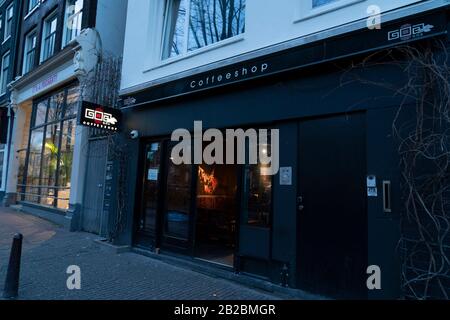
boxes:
[78,101,122,132]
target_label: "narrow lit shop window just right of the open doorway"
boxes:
[243,144,273,228]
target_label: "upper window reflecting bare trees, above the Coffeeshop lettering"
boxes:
[162,0,246,59]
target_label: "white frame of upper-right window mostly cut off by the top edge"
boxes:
[294,0,366,22]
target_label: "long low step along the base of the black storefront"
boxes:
[130,247,329,300]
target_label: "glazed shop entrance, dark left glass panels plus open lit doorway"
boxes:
[134,140,239,267]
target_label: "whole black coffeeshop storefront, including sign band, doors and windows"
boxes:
[111,5,448,299]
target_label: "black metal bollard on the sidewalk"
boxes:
[3,233,23,299]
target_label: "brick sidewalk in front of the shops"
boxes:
[0,208,282,300]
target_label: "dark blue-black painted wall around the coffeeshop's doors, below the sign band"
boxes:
[117,57,414,297]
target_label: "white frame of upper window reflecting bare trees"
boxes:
[161,0,247,62]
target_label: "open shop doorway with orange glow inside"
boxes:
[194,165,238,266]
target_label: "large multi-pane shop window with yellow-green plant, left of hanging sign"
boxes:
[19,86,79,210]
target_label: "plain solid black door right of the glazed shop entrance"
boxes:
[297,114,367,298]
